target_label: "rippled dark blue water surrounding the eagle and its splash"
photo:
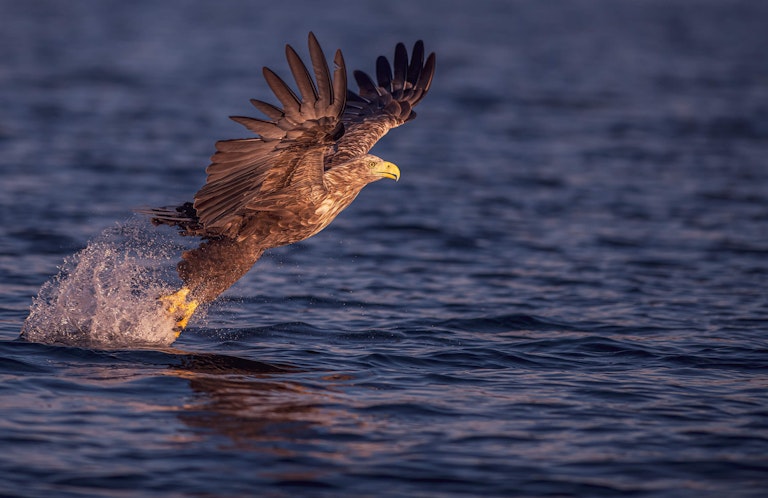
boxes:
[0,0,768,497]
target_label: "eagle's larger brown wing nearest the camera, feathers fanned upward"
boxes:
[194,33,347,237]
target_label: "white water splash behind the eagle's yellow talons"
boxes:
[21,217,196,349]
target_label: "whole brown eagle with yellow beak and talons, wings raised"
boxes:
[143,33,435,328]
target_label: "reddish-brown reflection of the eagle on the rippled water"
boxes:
[169,354,396,487]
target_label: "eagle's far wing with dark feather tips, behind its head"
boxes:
[326,40,435,166]
